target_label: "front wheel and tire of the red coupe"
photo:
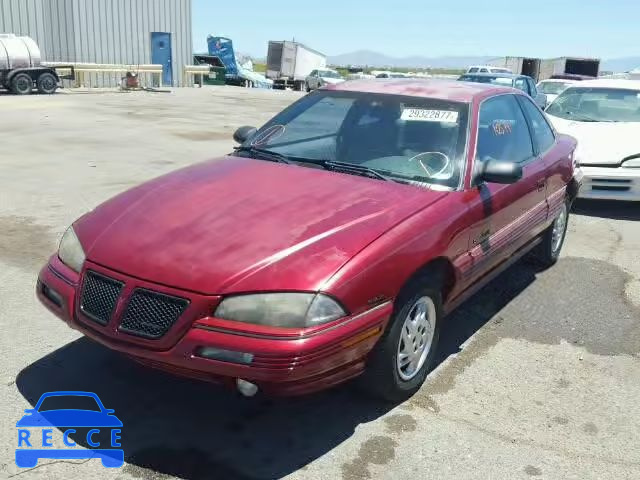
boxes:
[361,279,443,403]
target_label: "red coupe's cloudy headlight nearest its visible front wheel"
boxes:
[214,293,346,328]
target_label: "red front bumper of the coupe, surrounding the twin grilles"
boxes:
[37,255,392,395]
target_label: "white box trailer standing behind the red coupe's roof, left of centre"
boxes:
[267,41,327,91]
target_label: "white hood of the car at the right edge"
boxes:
[548,115,640,166]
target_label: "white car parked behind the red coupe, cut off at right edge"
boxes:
[546,80,640,201]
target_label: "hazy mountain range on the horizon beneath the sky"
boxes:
[327,50,640,72]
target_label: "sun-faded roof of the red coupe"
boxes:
[325,78,519,103]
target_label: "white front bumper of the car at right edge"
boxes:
[578,165,640,201]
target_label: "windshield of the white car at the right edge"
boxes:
[547,87,640,122]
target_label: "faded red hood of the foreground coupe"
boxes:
[74,157,447,294]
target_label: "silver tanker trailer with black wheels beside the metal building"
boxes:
[0,33,73,95]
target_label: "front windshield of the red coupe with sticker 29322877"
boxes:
[240,91,468,189]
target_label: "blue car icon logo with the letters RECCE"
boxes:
[16,391,124,468]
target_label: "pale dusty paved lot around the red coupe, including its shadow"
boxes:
[0,88,640,480]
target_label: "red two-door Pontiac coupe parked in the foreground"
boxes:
[37,79,579,401]
